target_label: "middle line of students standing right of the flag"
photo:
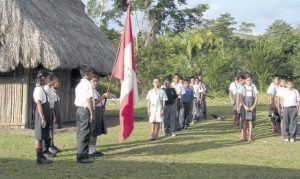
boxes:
[146,75,207,140]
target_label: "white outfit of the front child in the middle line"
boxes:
[146,89,168,123]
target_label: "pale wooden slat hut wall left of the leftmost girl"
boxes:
[0,71,30,128]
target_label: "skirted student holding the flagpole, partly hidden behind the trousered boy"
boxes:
[89,75,108,157]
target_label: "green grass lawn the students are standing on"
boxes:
[0,93,300,179]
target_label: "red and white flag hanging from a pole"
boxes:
[112,4,138,143]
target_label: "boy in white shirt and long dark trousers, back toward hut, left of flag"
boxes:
[74,65,95,163]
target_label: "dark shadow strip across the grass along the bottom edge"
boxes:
[0,157,300,179]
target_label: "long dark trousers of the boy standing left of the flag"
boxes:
[76,107,91,160]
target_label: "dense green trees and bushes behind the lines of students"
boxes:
[89,0,300,94]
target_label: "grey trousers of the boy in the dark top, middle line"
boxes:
[162,105,176,134]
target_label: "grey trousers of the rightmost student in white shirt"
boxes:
[282,106,298,139]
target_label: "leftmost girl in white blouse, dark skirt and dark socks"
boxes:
[33,70,54,164]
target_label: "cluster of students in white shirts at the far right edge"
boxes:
[267,75,300,142]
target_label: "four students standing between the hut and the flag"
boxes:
[33,65,109,164]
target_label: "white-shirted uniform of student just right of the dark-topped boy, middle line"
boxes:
[171,82,185,130]
